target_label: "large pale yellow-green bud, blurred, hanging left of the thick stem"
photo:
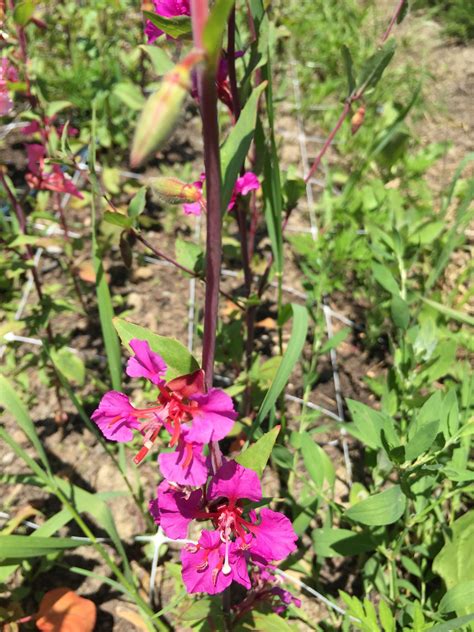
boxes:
[130,51,202,167]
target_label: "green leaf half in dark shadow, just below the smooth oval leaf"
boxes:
[311,527,378,557]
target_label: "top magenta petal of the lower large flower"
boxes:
[207,461,262,502]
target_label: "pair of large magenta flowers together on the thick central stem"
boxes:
[92,339,297,608]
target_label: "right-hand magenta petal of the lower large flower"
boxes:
[251,509,298,561]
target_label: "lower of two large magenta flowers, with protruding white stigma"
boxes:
[150,461,297,594]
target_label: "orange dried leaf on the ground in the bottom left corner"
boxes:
[36,588,97,632]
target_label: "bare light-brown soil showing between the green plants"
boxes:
[0,3,474,632]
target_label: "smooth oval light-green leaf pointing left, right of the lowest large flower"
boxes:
[344,485,407,526]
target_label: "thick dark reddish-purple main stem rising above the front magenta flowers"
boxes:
[191,0,222,468]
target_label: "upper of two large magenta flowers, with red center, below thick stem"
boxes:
[92,339,237,486]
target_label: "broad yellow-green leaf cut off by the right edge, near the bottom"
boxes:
[433,510,474,590]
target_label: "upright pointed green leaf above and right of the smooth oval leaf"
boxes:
[405,391,442,461]
